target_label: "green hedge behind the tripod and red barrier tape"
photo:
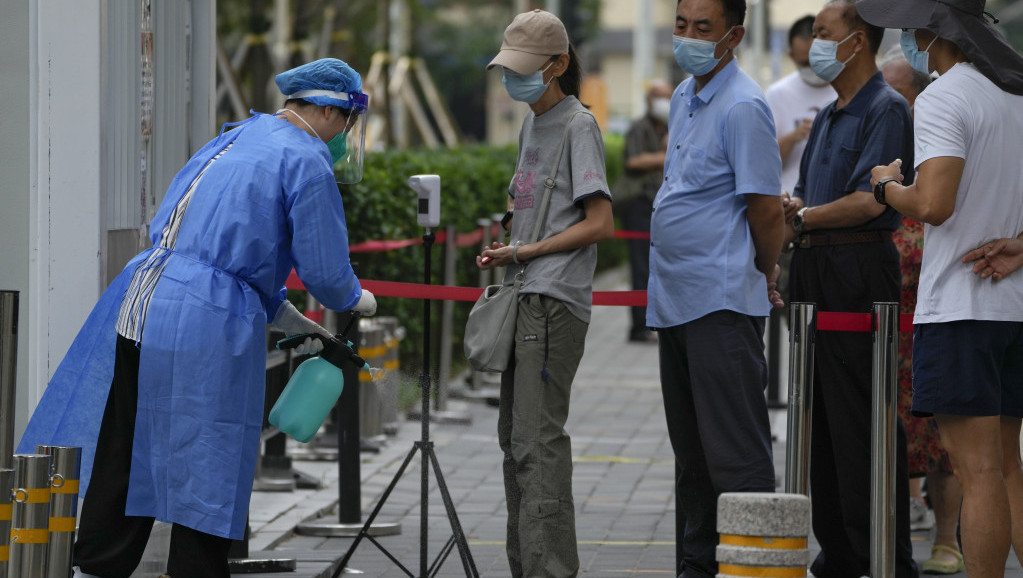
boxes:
[297,135,626,376]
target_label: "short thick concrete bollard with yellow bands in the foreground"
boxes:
[716,493,810,578]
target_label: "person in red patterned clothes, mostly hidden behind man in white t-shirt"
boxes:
[881,46,964,574]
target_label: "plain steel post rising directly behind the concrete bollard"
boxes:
[785,303,817,495]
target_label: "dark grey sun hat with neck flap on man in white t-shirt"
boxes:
[856,0,1023,94]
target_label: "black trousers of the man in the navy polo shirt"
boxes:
[791,241,918,578]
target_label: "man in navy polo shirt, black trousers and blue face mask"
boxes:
[789,0,918,578]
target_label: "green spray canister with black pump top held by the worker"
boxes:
[270,334,369,442]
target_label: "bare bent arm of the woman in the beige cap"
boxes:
[476,194,615,269]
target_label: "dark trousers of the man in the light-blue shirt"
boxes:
[658,311,774,578]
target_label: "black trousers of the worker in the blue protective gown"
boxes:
[75,336,231,578]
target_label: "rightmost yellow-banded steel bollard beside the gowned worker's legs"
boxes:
[36,445,82,578]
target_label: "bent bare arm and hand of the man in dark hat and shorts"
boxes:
[871,157,966,225]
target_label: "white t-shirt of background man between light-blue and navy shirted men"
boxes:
[764,72,838,192]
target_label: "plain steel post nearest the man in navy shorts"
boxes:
[871,303,898,576]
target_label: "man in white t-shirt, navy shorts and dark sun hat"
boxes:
[857,0,1023,578]
